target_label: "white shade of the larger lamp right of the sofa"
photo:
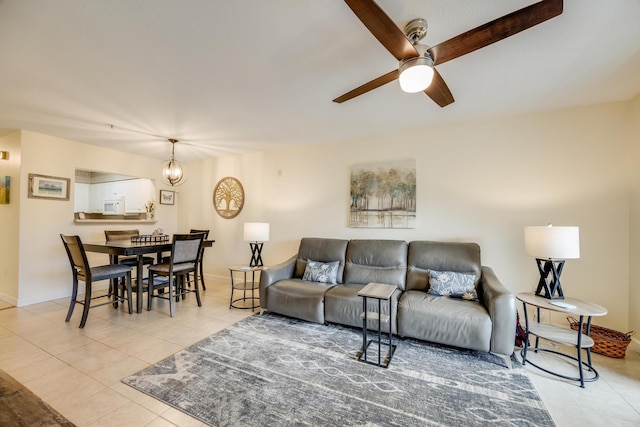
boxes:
[524,225,580,259]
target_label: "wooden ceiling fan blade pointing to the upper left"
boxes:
[344,0,418,61]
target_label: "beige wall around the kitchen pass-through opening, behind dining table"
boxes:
[10,131,177,306]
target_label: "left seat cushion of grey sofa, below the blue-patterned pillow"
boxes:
[267,279,332,323]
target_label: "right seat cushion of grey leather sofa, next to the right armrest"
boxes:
[398,290,492,351]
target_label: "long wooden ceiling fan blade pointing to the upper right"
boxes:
[428,0,563,65]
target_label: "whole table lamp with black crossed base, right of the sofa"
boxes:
[524,224,580,300]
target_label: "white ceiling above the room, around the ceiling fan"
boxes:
[0,0,640,161]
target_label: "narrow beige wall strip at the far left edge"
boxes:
[0,131,21,304]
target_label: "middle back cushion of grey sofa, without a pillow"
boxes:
[342,240,407,290]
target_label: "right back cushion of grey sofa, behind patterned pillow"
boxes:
[406,240,482,291]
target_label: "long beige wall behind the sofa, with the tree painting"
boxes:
[189,103,630,329]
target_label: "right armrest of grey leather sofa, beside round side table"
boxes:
[480,266,516,356]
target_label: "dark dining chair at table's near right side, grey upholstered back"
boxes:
[147,233,204,317]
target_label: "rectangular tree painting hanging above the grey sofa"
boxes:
[349,159,416,228]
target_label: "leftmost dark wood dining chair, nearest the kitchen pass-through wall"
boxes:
[60,234,133,328]
